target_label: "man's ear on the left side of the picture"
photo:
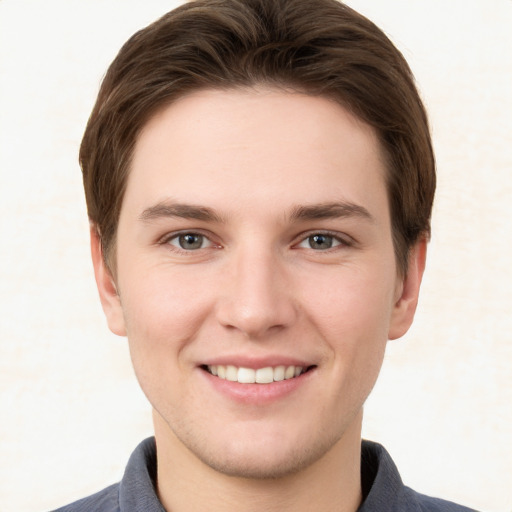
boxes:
[90,224,126,336]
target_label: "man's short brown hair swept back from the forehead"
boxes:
[80,0,435,274]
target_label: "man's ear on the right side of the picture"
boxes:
[388,237,427,340]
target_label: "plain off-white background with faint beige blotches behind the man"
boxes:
[0,0,512,512]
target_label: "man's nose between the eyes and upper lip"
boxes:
[217,245,297,339]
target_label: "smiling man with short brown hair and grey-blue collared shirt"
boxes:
[55,0,476,512]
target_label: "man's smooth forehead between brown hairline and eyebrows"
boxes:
[123,88,387,222]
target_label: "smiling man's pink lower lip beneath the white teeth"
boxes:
[200,368,315,405]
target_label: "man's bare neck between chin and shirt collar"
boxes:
[154,412,362,512]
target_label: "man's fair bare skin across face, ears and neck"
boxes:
[91,88,425,512]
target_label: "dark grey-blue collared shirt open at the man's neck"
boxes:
[54,437,475,512]
